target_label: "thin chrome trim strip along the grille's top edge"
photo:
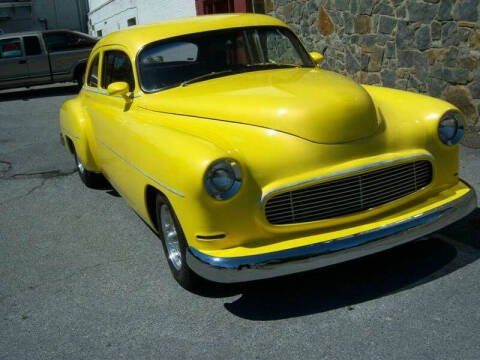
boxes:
[260,154,433,207]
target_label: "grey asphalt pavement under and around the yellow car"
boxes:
[0,86,480,360]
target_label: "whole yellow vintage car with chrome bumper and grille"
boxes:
[60,14,476,289]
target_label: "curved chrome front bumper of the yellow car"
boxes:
[187,181,477,283]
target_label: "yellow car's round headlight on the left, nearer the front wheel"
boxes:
[204,159,242,200]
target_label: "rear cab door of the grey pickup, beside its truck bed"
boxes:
[23,35,51,85]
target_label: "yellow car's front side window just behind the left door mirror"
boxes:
[102,51,135,91]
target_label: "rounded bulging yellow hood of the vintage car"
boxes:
[140,68,379,144]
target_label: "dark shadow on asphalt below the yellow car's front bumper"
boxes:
[196,209,480,321]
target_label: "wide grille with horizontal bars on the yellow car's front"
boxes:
[265,160,432,225]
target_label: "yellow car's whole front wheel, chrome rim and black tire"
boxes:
[155,193,202,291]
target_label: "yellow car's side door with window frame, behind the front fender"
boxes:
[87,48,135,196]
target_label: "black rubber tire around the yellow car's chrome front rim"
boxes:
[155,193,205,292]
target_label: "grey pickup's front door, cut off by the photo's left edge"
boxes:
[0,36,29,89]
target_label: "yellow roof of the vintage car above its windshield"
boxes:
[93,14,287,56]
